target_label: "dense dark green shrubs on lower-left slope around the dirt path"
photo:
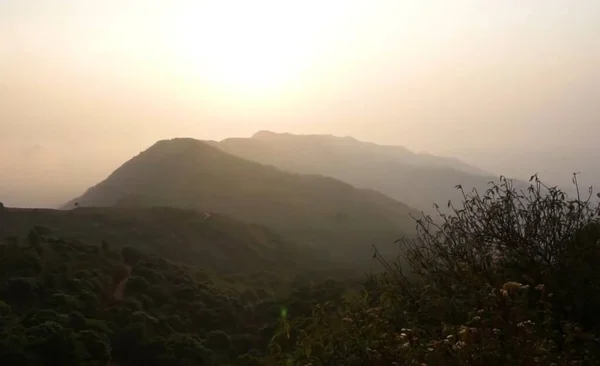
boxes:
[0,227,356,365]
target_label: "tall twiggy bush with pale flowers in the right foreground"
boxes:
[269,176,600,366]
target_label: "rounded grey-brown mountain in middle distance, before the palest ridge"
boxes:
[65,139,416,258]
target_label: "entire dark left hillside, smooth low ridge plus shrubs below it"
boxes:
[0,212,360,366]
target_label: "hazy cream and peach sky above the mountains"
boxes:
[0,0,600,206]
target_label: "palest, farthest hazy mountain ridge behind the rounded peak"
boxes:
[212,131,526,212]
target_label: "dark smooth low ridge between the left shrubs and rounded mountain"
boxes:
[4,207,318,272]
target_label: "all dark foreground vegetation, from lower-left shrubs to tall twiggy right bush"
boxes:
[0,177,600,366]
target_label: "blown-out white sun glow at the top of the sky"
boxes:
[165,0,360,95]
